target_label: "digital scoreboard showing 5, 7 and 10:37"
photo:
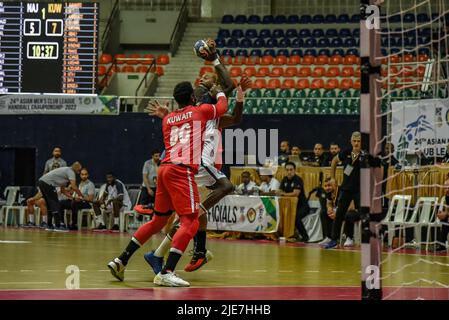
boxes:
[0,2,99,94]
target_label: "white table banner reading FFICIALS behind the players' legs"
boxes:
[207,195,279,233]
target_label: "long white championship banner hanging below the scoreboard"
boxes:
[0,94,119,115]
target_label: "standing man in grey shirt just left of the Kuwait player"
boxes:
[139,150,161,205]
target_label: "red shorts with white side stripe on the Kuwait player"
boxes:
[154,164,200,215]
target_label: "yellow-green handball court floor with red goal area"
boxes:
[0,227,449,300]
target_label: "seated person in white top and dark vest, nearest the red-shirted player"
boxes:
[92,172,132,231]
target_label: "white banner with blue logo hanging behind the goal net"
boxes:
[391,99,449,161]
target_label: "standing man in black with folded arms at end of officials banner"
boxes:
[277,162,310,242]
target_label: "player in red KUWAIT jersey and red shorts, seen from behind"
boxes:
[108,82,228,287]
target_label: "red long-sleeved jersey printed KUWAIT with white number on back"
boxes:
[162,93,228,173]
